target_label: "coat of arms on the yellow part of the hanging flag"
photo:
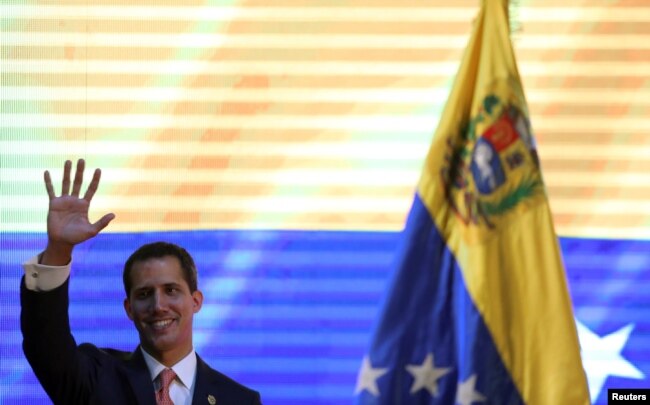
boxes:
[440,81,545,234]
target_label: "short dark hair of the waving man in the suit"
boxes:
[122,242,198,298]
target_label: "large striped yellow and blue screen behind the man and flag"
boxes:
[0,0,650,404]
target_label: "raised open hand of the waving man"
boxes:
[41,159,115,265]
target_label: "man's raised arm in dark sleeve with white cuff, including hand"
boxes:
[21,160,115,404]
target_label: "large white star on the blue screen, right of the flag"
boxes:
[576,320,645,401]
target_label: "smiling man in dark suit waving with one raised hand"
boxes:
[21,160,261,405]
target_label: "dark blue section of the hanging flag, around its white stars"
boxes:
[359,195,522,405]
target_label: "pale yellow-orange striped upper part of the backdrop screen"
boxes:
[0,0,650,238]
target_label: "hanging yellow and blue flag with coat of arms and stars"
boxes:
[355,0,589,405]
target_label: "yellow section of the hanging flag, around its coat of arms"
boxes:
[418,0,588,405]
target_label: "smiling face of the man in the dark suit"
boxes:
[124,256,203,366]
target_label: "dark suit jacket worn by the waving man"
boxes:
[20,279,261,405]
